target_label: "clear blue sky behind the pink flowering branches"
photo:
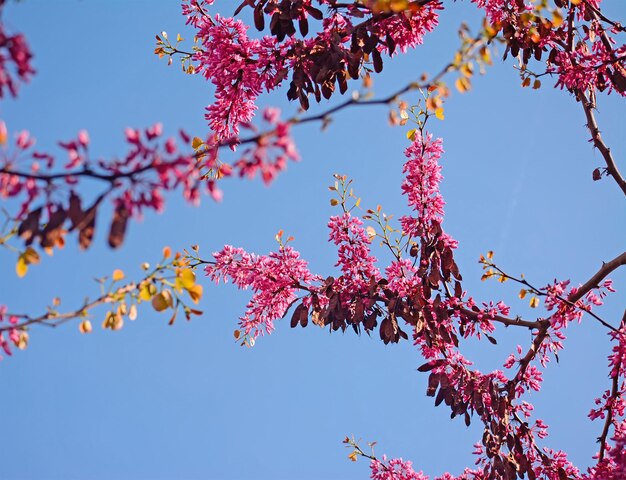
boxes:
[0,0,626,480]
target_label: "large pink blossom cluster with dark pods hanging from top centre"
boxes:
[183,0,442,138]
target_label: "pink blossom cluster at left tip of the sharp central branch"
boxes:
[206,245,321,338]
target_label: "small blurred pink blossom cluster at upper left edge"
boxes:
[0,21,35,98]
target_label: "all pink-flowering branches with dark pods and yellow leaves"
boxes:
[0,0,626,480]
